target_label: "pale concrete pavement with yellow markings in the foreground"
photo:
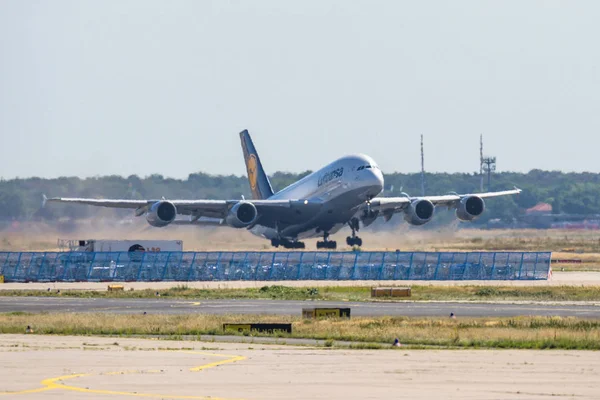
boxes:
[0,335,600,400]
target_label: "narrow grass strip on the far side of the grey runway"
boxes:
[0,285,600,301]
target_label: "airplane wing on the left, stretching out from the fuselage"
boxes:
[43,196,321,225]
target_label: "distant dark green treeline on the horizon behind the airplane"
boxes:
[0,170,600,223]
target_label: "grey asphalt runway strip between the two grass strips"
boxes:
[0,297,600,319]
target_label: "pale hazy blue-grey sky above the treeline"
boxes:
[0,0,600,179]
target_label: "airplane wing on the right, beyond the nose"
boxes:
[362,188,521,214]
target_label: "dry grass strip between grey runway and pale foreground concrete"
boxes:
[0,313,600,350]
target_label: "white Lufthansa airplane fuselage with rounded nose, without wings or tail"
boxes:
[251,155,383,239]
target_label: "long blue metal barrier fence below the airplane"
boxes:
[0,252,551,282]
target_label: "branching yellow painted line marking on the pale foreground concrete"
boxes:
[0,351,246,400]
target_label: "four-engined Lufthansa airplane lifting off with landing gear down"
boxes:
[43,130,521,249]
